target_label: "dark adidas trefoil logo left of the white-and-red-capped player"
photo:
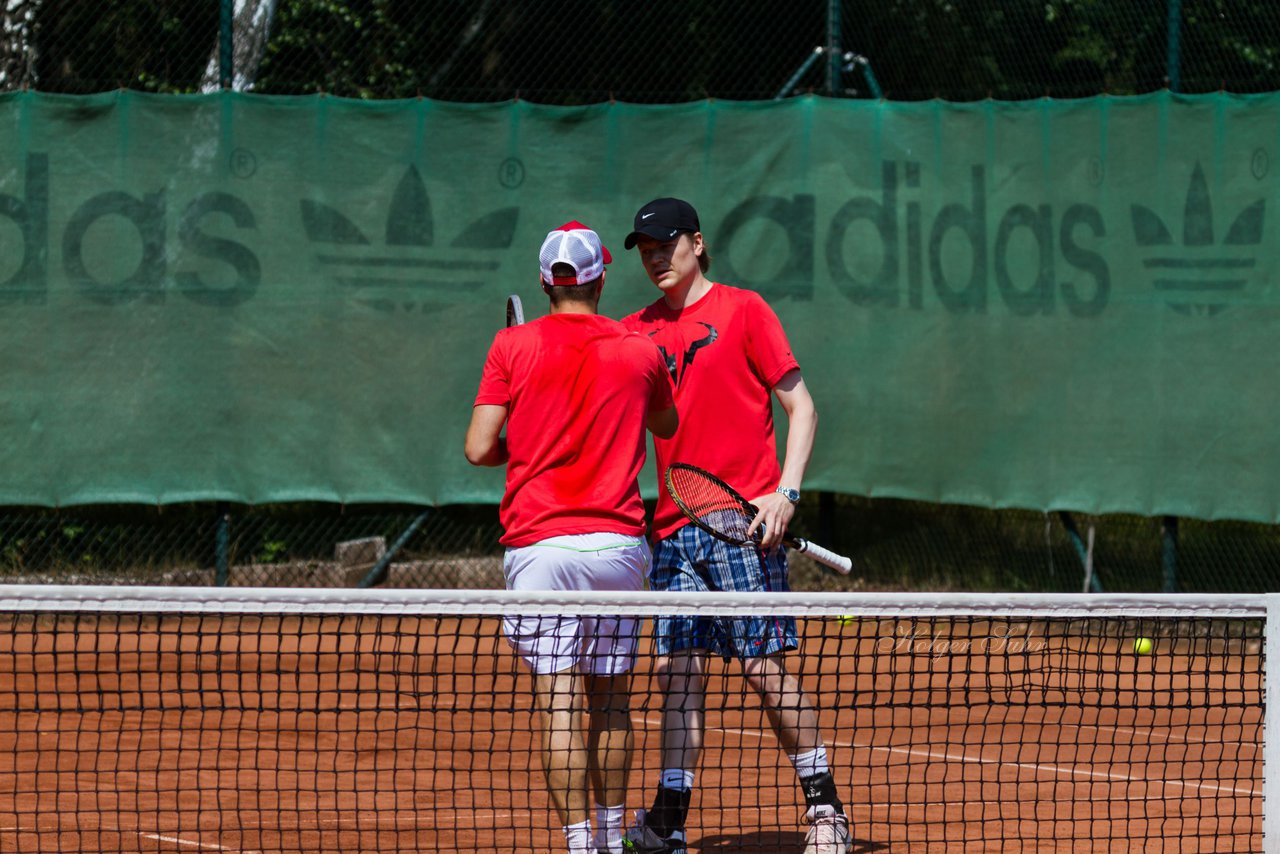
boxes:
[300,165,520,312]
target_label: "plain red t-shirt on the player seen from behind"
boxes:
[476,314,672,547]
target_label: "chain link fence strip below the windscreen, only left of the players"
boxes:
[0,503,503,588]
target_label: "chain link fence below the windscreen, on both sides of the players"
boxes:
[0,504,1280,593]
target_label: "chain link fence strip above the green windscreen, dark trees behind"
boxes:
[0,0,1280,104]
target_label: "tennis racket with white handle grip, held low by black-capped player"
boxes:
[664,462,854,575]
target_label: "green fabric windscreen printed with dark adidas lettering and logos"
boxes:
[0,92,1280,522]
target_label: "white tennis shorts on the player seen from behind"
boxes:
[503,534,650,675]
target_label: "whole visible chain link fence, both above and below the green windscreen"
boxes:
[0,0,1280,592]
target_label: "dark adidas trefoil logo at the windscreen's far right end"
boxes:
[1130,163,1266,316]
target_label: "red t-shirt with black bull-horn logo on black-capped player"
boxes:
[622,284,800,539]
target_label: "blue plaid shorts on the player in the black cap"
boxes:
[649,525,799,658]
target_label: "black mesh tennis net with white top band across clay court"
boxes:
[0,585,1264,854]
